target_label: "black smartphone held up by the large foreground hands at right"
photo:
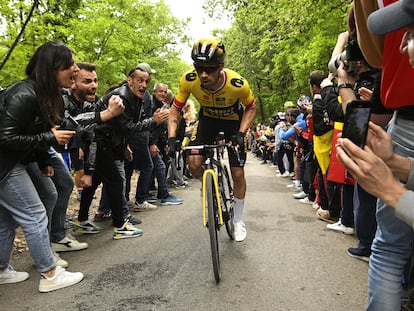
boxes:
[342,100,371,148]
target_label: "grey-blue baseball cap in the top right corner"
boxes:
[368,0,414,35]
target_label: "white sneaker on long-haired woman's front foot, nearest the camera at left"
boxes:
[39,266,83,293]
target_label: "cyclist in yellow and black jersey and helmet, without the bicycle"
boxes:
[168,38,256,242]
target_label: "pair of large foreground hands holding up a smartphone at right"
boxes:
[337,122,414,216]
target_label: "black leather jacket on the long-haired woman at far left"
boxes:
[0,79,57,182]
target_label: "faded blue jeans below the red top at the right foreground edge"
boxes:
[367,116,414,311]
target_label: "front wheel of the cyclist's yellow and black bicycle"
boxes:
[206,174,220,283]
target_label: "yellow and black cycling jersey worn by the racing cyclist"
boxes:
[174,68,256,121]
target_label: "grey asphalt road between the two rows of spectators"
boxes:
[0,154,368,311]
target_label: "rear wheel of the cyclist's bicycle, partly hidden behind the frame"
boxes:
[220,165,234,240]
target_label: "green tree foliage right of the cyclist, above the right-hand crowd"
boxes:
[221,0,350,121]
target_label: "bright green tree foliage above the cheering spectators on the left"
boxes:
[0,0,188,93]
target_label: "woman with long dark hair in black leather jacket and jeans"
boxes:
[0,42,83,292]
